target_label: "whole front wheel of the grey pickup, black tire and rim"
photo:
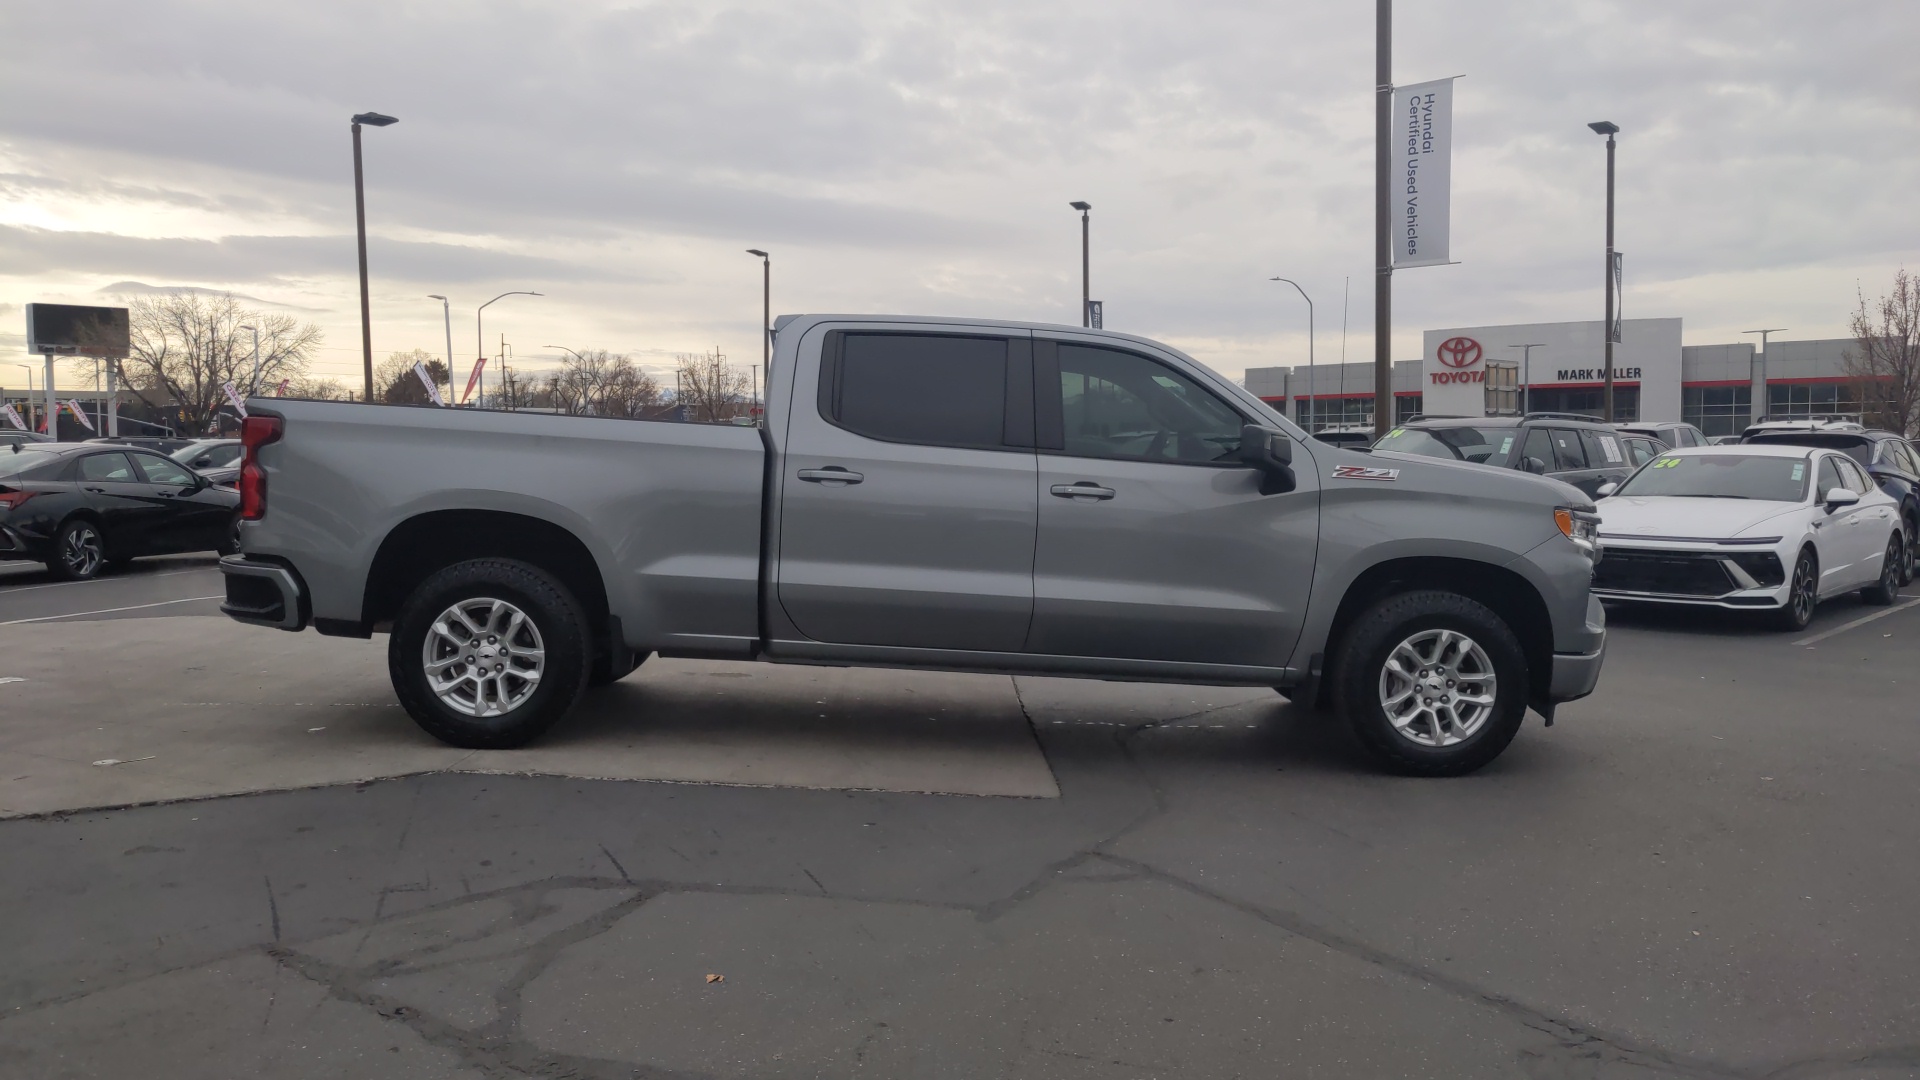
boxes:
[1334,590,1530,776]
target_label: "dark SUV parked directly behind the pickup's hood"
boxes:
[1373,413,1643,496]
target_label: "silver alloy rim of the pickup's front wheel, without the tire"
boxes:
[1379,628,1500,748]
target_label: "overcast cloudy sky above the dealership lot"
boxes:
[0,0,1920,388]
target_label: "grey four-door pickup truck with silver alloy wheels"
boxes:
[221,315,1605,774]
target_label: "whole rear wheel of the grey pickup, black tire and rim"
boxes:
[386,559,591,749]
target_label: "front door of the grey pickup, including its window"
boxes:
[1027,340,1334,667]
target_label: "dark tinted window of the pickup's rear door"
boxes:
[822,334,1006,448]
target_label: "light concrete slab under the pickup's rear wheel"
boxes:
[0,617,1060,817]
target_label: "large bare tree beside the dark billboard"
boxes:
[123,292,321,432]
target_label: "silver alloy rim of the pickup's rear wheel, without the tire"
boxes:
[420,596,547,717]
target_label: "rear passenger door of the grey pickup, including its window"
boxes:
[778,329,1037,651]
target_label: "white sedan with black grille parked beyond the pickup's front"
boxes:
[1594,444,1908,630]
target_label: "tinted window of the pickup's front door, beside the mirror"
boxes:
[1060,344,1246,465]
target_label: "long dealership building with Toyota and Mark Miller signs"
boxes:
[1246,319,1860,434]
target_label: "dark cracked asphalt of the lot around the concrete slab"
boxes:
[0,559,1920,1078]
